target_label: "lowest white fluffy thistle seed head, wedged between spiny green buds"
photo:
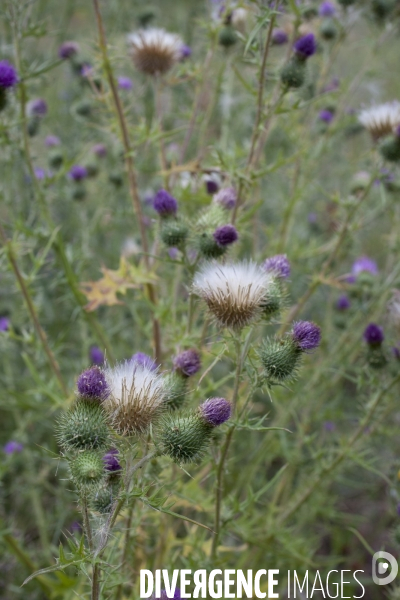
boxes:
[104,361,168,435]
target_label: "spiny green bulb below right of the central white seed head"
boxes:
[260,338,301,382]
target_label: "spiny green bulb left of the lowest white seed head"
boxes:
[57,400,110,450]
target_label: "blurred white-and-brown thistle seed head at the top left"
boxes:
[128,29,184,75]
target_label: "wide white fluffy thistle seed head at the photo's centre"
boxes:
[193,261,273,329]
